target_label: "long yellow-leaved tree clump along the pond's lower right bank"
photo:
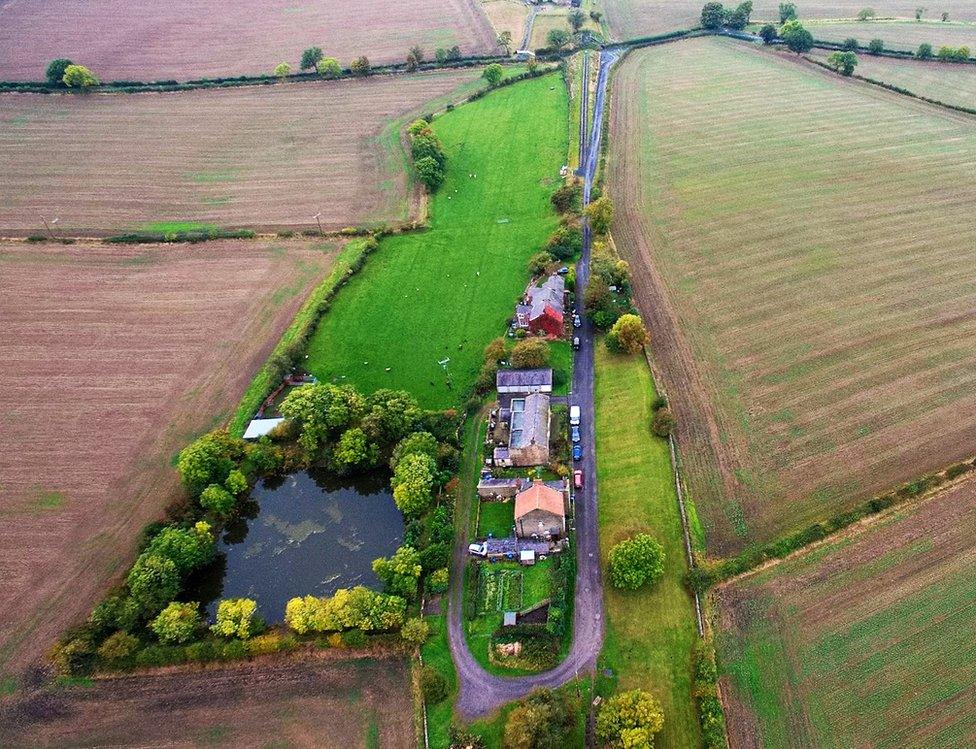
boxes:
[285,585,407,635]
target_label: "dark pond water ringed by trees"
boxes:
[183,471,403,622]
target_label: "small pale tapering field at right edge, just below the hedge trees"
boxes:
[812,52,976,109]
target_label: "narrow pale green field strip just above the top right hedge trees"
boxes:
[807,20,976,51]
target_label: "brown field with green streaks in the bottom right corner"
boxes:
[715,479,976,749]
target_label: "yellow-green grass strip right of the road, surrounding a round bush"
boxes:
[596,343,700,749]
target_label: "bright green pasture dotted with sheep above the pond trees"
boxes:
[307,75,568,407]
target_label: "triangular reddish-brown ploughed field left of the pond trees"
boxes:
[0,241,334,675]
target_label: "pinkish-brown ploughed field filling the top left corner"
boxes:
[0,0,496,81]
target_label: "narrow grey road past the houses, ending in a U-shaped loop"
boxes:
[448,46,619,720]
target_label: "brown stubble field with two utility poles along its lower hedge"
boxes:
[0,70,496,235]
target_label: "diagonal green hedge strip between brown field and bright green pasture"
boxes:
[228,237,379,437]
